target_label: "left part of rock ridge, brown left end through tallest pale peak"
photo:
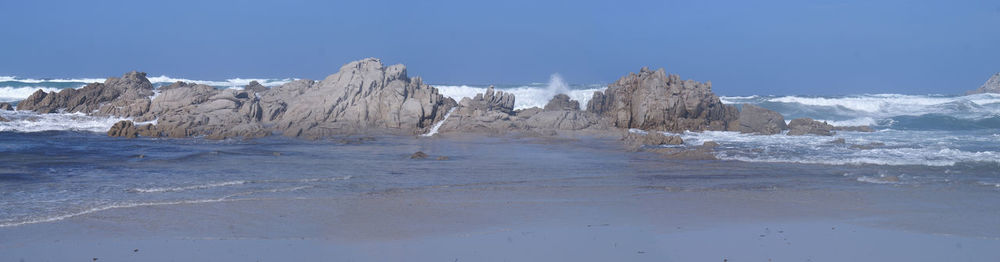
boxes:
[18,58,458,139]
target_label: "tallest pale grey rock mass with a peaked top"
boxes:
[260,58,458,137]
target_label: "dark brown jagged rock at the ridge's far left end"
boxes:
[17,71,153,117]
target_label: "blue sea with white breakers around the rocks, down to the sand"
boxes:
[0,75,1000,231]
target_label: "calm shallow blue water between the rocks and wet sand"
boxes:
[0,131,1000,236]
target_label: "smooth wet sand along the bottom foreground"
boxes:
[0,175,1000,261]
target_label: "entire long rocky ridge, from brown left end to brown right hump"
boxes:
[11,58,752,143]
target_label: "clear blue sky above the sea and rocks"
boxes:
[0,0,1000,95]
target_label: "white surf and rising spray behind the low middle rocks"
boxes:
[434,74,604,109]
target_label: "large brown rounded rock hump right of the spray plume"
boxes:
[587,68,739,132]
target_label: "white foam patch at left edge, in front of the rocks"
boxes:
[0,111,127,133]
